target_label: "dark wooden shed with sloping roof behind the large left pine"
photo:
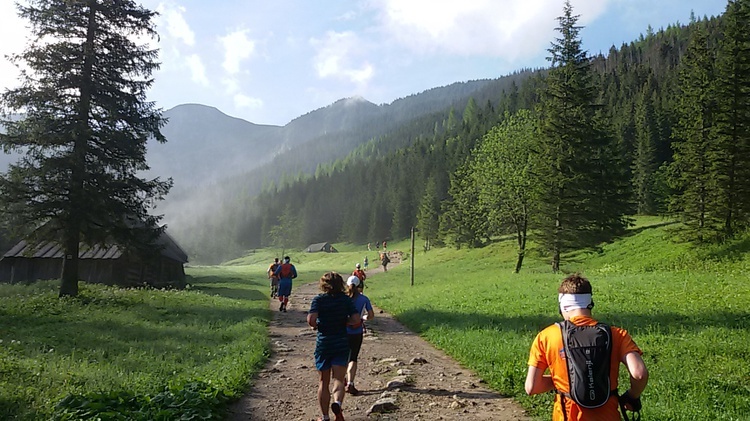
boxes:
[0,232,188,288]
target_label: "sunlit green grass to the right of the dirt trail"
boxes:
[368,218,750,421]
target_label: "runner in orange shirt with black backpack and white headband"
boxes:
[525,274,648,421]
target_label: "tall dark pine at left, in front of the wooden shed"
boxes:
[0,0,171,296]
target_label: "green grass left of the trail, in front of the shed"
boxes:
[0,268,270,420]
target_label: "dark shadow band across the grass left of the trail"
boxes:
[2,288,270,371]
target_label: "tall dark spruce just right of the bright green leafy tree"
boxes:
[538,2,628,272]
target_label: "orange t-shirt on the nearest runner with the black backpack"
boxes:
[529,316,643,421]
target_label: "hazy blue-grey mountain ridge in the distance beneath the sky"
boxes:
[148,80,506,194]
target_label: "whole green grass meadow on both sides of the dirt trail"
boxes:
[0,218,750,421]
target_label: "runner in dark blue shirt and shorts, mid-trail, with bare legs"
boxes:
[307,272,362,421]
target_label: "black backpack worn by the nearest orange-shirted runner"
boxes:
[556,320,617,408]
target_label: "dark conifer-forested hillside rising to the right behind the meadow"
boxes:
[184,3,750,268]
